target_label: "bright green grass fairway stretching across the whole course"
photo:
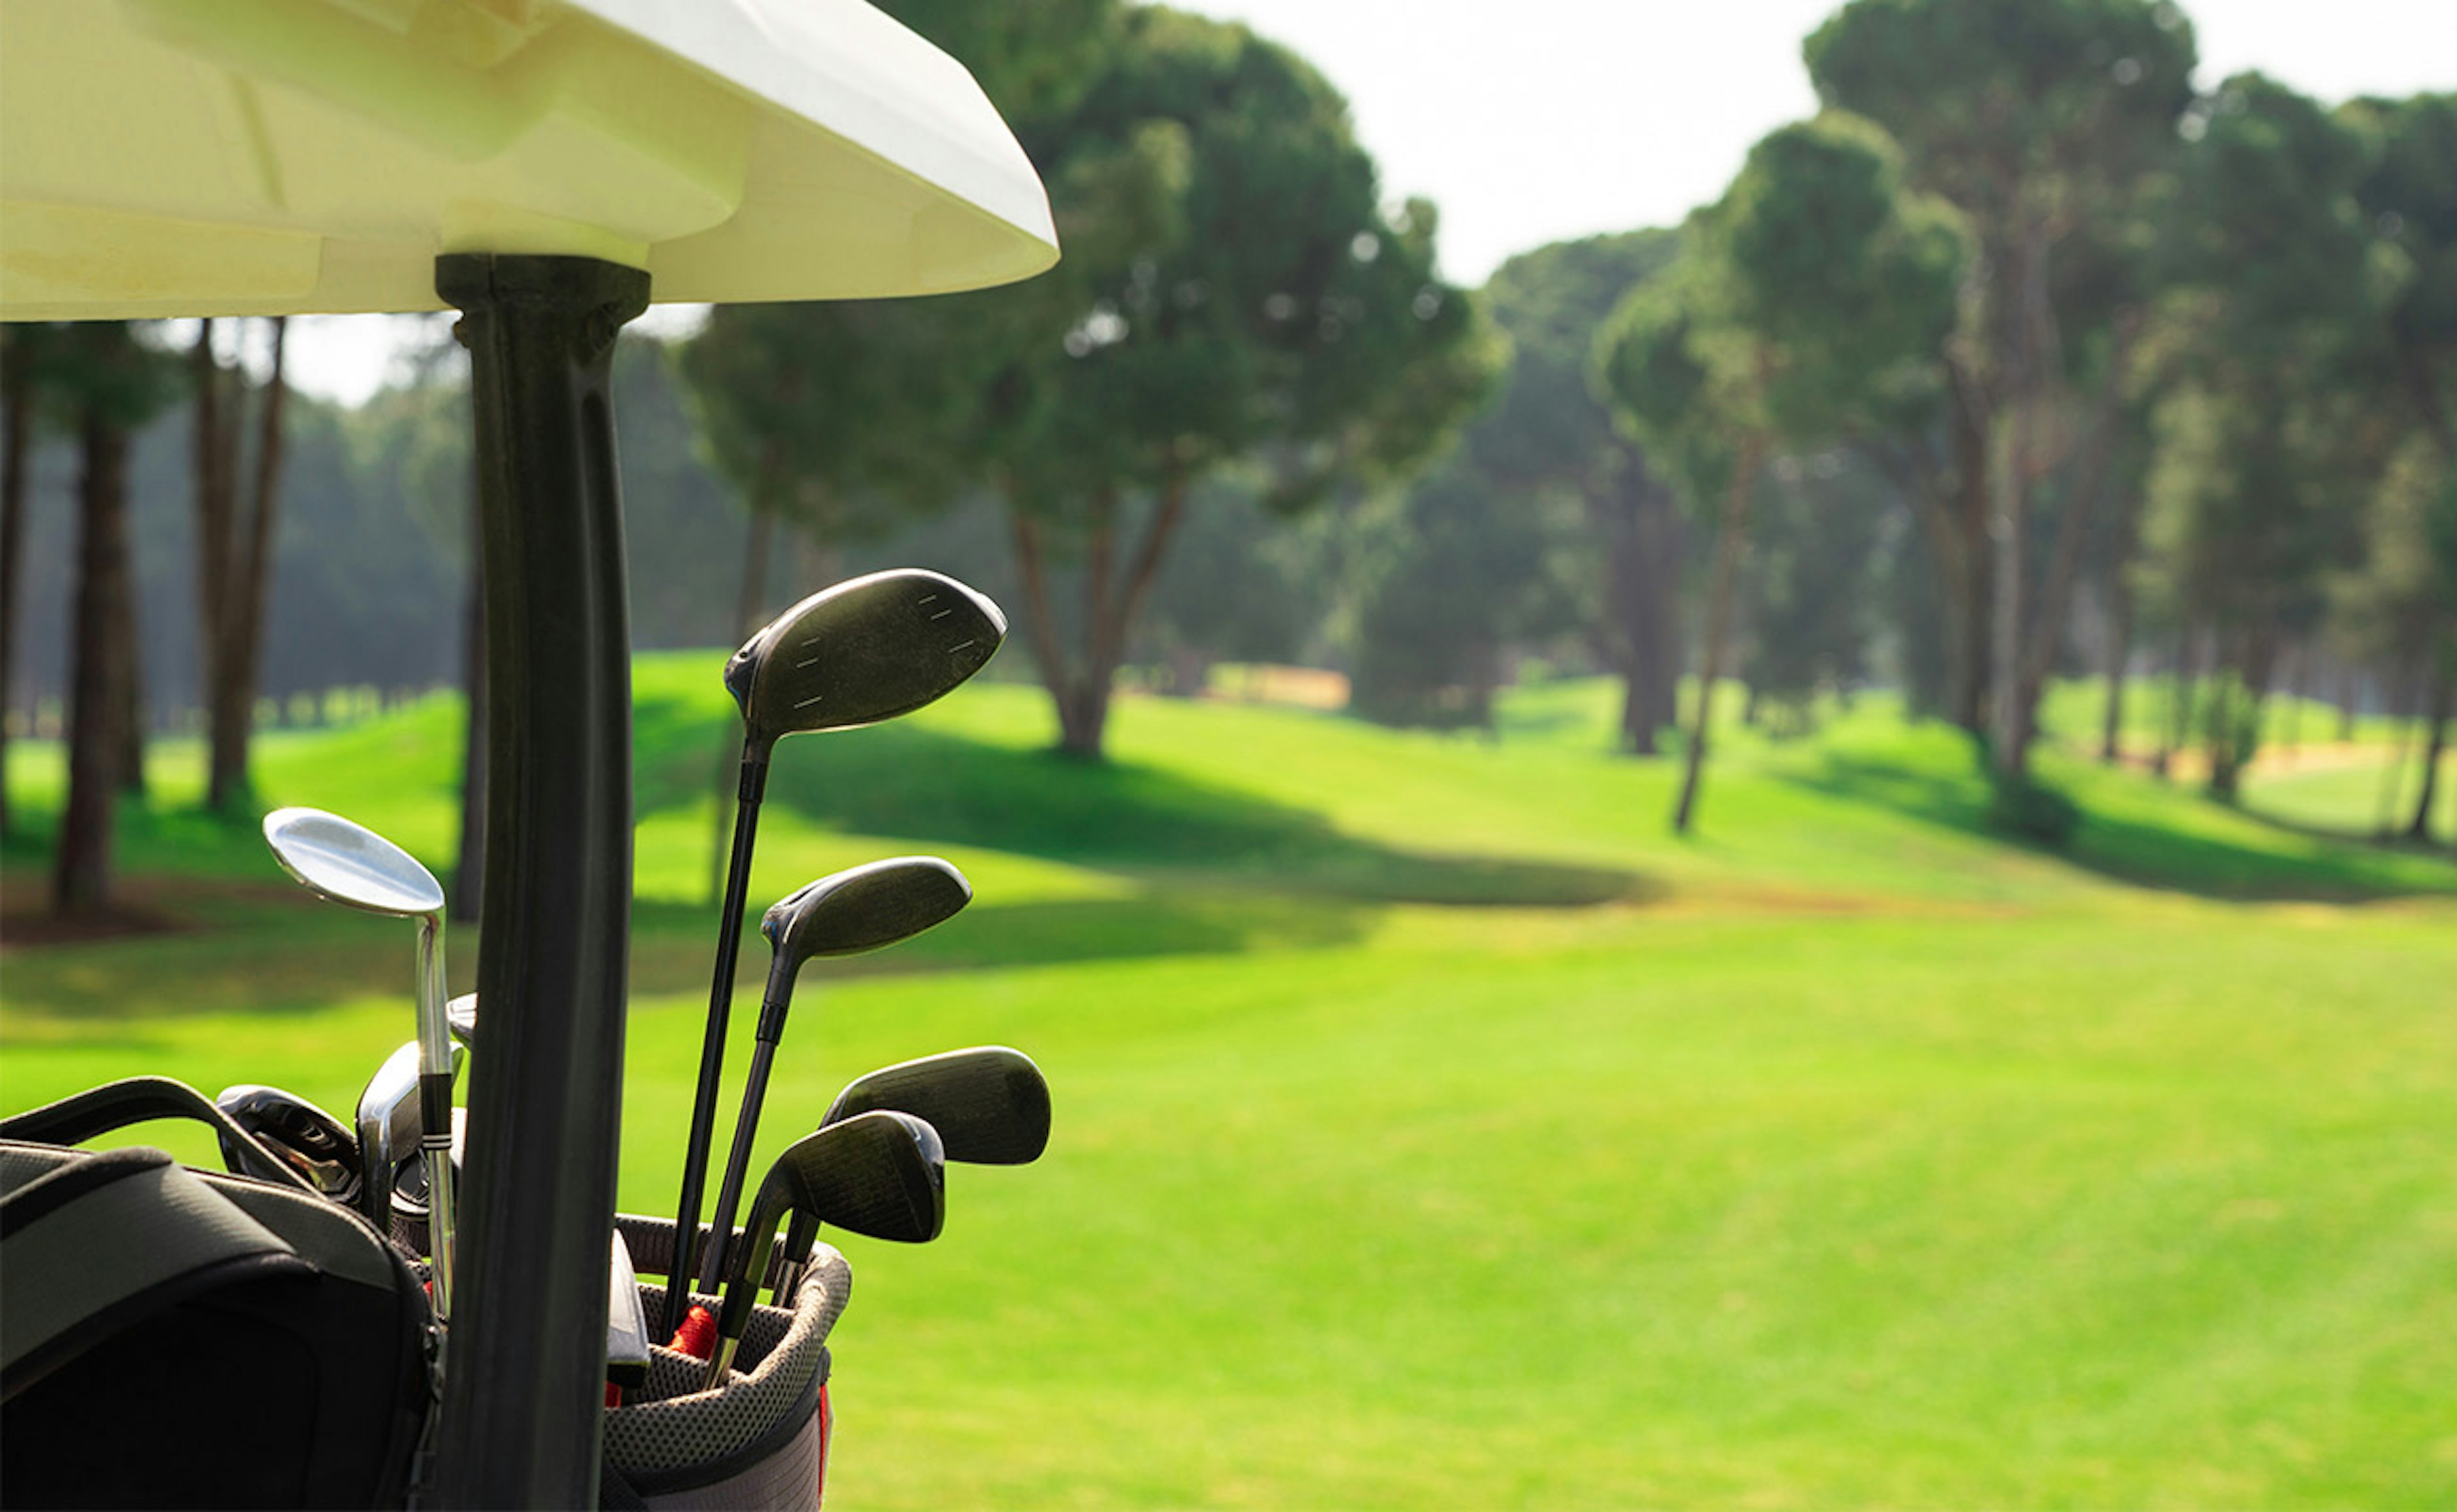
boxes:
[0,654,2457,1509]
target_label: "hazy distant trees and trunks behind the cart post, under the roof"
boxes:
[0,322,742,914]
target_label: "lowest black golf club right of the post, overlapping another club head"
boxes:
[708,1111,946,1389]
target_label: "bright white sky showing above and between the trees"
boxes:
[285,0,2457,403]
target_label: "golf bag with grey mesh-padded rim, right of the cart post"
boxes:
[605,1214,852,1512]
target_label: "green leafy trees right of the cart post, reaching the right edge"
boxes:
[663,0,2457,838]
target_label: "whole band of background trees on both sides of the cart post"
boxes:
[0,0,2457,924]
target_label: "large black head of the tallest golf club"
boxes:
[725,568,1007,760]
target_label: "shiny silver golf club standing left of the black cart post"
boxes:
[266,809,457,1323]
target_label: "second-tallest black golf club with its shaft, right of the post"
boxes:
[692,855,973,1310]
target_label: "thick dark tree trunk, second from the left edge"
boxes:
[52,403,131,917]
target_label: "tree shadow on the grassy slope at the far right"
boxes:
[1786,752,2457,902]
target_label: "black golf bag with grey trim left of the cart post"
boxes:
[0,1077,433,1507]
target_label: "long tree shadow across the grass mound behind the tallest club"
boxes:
[639,706,1664,907]
